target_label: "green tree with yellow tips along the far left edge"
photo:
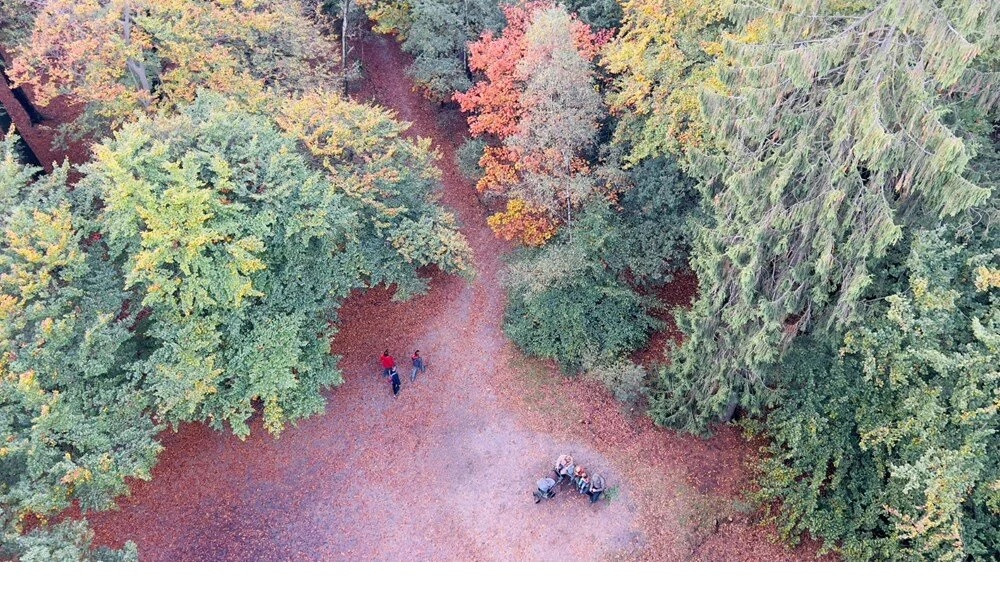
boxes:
[0,137,161,560]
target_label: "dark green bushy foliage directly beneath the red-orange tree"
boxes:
[505,153,697,373]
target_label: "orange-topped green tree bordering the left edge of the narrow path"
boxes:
[277,93,474,299]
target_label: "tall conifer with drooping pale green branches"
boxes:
[652,0,1000,430]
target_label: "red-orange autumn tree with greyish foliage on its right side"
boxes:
[455,0,608,246]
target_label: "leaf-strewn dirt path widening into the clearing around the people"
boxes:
[84,36,815,560]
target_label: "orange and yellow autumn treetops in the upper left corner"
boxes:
[9,0,337,136]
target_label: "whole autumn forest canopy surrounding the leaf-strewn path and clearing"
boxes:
[0,0,1000,561]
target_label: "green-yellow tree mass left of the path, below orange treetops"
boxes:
[0,88,471,559]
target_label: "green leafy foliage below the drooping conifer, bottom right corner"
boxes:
[760,231,1000,560]
